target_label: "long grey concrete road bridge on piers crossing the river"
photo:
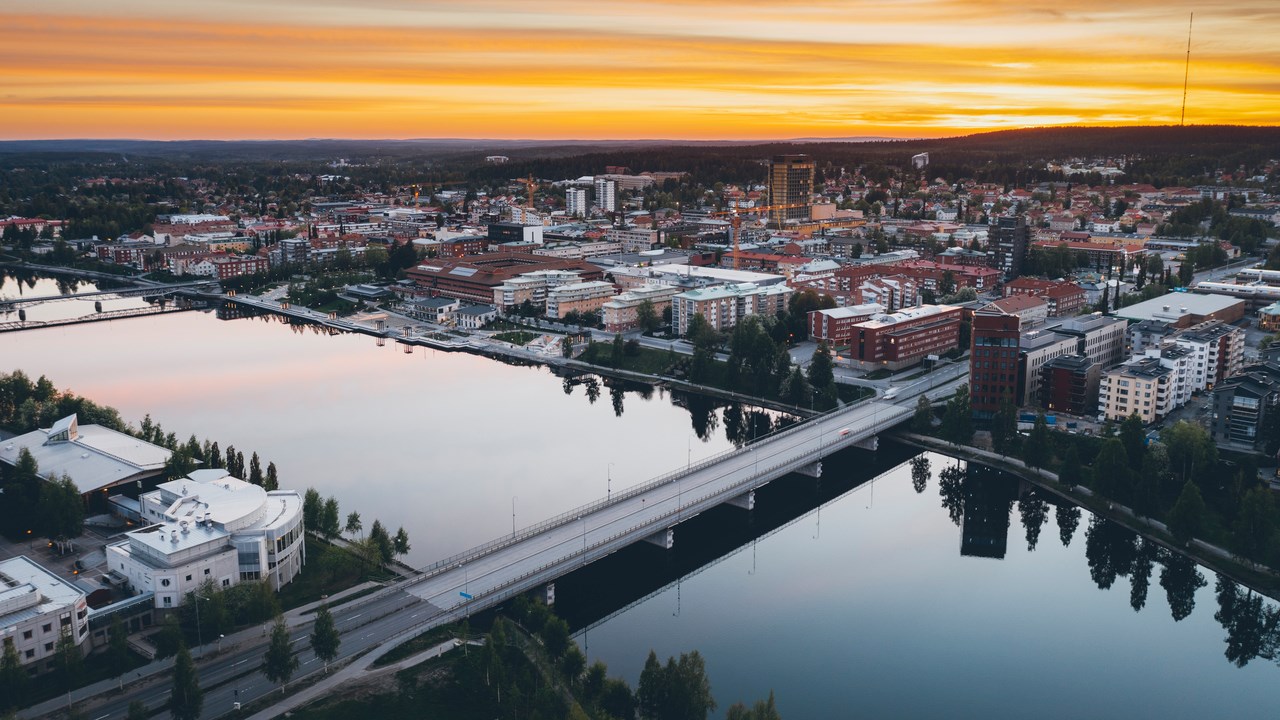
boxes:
[384,364,968,627]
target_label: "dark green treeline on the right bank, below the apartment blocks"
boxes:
[931,387,1280,568]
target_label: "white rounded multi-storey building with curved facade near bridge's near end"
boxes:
[105,469,306,609]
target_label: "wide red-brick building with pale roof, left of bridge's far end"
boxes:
[849,305,961,370]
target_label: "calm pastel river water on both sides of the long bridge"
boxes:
[0,271,1280,720]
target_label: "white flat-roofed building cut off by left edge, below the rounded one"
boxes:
[0,556,88,674]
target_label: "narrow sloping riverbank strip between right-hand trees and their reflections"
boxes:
[893,430,1280,600]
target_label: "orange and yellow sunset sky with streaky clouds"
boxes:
[0,0,1280,140]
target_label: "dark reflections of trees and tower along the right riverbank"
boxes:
[931,455,1280,667]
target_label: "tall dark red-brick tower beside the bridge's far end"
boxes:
[969,307,1021,418]
